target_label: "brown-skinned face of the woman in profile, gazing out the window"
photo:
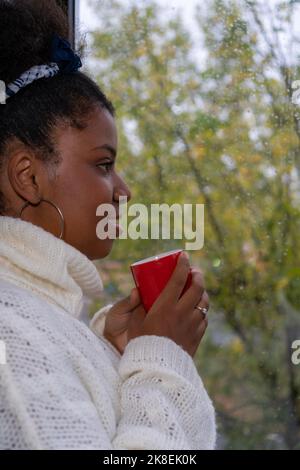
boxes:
[3,107,131,260]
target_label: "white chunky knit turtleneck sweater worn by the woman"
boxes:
[0,217,216,450]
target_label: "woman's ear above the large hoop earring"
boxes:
[7,147,42,204]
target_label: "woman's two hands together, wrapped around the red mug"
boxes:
[103,255,209,357]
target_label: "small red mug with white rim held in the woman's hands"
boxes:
[130,249,192,312]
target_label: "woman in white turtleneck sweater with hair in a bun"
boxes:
[0,0,216,449]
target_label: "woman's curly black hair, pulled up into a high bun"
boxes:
[0,0,115,215]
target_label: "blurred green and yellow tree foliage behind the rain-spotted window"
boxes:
[84,0,300,449]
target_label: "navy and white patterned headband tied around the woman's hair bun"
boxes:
[6,34,82,99]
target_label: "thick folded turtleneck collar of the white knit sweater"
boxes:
[0,216,103,318]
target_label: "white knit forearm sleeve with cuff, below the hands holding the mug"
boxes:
[113,336,216,450]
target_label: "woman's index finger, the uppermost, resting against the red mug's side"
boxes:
[157,251,190,306]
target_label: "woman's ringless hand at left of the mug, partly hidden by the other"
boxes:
[103,287,141,354]
